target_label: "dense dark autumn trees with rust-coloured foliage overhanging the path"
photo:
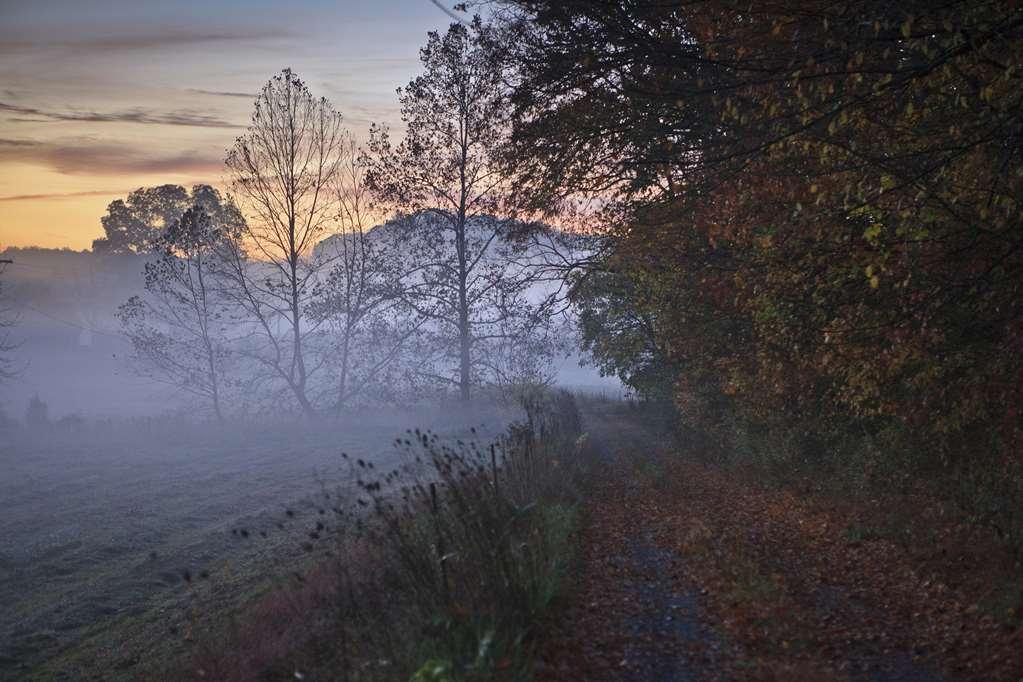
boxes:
[486,0,1023,543]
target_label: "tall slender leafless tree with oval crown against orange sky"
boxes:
[226,70,347,416]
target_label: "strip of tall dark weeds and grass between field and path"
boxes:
[183,392,586,682]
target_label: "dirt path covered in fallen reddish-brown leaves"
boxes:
[538,405,1023,682]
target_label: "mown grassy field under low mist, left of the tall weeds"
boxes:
[0,409,513,680]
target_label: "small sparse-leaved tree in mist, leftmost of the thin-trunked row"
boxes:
[118,206,243,422]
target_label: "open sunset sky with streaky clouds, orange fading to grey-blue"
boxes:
[0,0,460,249]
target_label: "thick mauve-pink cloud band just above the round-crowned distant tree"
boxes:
[0,138,224,175]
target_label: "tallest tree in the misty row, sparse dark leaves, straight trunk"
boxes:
[367,17,556,401]
